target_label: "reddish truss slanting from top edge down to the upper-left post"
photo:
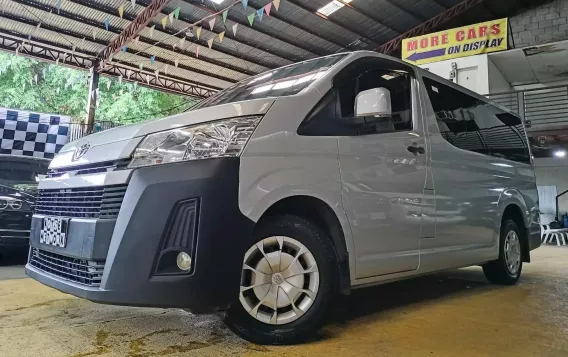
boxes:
[98,0,171,63]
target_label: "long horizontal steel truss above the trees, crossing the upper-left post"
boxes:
[0,31,219,98]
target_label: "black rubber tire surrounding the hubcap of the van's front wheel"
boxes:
[225,216,339,344]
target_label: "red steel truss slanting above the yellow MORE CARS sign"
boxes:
[375,0,485,54]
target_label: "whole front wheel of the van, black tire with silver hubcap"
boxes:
[225,215,339,345]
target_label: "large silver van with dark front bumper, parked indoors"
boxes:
[26,52,540,344]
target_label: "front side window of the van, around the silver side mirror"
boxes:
[298,58,414,136]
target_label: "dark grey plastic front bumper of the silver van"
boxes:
[26,158,253,312]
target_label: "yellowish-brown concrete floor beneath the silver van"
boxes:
[0,246,568,357]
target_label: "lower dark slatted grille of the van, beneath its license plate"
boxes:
[29,247,105,287]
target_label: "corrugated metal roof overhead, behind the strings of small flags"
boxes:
[0,0,546,96]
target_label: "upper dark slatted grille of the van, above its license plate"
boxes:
[34,185,127,219]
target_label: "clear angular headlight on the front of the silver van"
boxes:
[128,116,261,168]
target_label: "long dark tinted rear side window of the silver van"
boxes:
[424,78,530,163]
